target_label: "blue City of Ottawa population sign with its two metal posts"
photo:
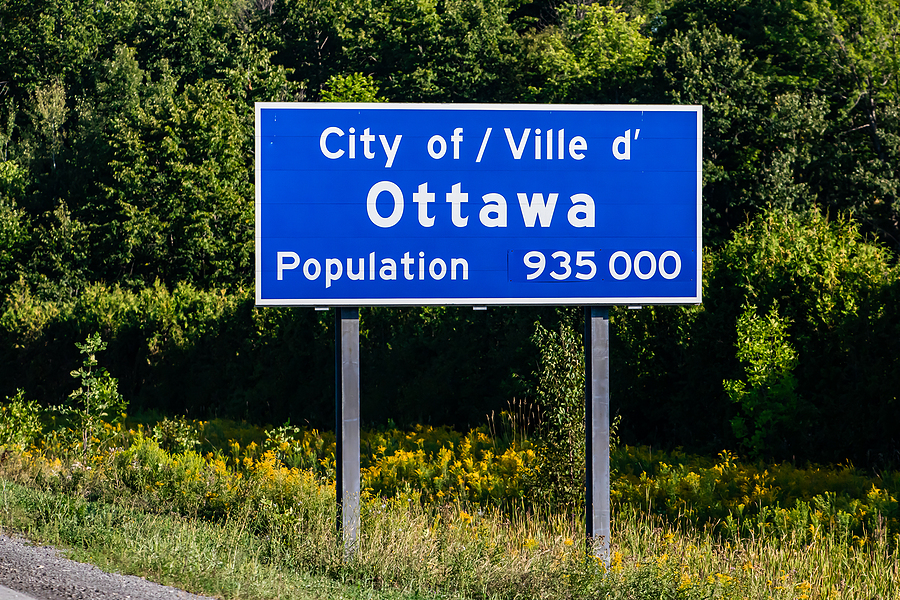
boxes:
[256,103,702,556]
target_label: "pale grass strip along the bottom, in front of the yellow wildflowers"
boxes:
[0,464,900,600]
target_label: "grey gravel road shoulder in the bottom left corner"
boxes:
[0,534,216,600]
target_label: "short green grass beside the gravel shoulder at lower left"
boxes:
[0,480,434,600]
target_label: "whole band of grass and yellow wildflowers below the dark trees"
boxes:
[0,335,900,599]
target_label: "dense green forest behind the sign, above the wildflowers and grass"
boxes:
[0,0,900,466]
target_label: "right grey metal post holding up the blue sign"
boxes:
[584,306,610,565]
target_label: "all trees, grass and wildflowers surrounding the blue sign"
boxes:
[0,0,900,600]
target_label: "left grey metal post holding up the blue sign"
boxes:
[334,308,359,556]
